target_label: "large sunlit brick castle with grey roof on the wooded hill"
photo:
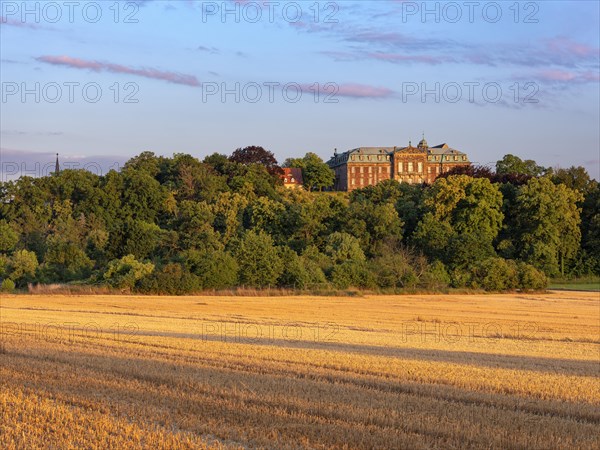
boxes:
[327,136,471,191]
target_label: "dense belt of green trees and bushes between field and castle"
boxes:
[0,147,600,294]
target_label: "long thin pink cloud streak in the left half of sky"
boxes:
[36,56,200,87]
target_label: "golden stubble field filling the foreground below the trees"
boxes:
[0,292,600,449]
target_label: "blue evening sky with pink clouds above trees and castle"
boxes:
[0,0,600,180]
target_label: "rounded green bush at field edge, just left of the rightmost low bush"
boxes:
[471,258,519,291]
